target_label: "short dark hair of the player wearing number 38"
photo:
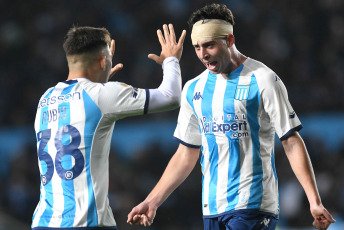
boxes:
[63,26,111,56]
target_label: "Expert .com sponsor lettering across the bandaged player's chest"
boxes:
[200,114,249,139]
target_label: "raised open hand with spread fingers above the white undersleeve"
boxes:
[148,24,186,65]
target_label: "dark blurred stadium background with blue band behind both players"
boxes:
[0,0,344,230]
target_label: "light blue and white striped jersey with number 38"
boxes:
[31,78,149,229]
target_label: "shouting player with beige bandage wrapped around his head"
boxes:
[128,4,334,230]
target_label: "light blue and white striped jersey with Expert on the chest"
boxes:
[174,58,302,217]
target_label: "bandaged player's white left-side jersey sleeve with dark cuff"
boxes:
[173,84,202,148]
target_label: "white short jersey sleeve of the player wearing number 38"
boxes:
[98,82,149,120]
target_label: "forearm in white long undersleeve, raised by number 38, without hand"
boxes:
[148,57,182,113]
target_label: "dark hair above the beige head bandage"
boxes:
[188,3,234,29]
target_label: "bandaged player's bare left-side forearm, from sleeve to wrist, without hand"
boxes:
[146,145,199,208]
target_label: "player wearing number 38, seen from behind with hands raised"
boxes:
[31,24,186,230]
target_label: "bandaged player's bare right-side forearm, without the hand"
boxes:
[282,133,321,206]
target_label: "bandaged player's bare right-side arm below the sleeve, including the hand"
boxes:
[282,132,335,229]
